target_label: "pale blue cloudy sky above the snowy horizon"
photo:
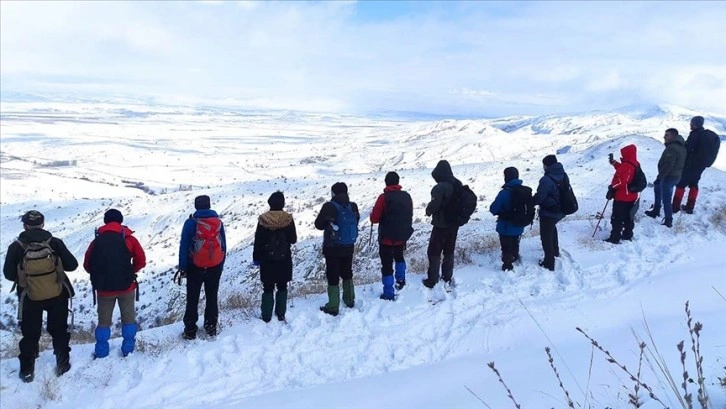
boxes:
[0,1,726,116]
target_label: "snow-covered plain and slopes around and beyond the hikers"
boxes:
[0,102,726,408]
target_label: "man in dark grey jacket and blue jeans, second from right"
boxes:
[645,128,687,227]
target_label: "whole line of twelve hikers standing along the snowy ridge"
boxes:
[3,116,720,382]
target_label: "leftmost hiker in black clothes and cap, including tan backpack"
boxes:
[3,210,78,382]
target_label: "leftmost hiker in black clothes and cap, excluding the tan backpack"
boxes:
[3,210,78,382]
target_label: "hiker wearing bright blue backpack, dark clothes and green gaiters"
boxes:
[315,182,360,316]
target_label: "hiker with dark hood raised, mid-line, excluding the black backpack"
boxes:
[422,160,461,288]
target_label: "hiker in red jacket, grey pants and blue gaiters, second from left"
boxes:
[83,209,146,358]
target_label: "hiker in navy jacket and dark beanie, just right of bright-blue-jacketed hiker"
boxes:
[533,155,570,271]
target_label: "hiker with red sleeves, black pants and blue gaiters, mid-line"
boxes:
[370,172,413,301]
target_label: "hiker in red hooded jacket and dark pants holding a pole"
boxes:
[605,144,640,244]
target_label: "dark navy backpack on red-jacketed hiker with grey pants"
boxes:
[88,229,136,291]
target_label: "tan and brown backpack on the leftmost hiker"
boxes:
[17,237,65,301]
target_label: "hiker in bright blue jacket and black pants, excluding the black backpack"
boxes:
[489,167,524,271]
